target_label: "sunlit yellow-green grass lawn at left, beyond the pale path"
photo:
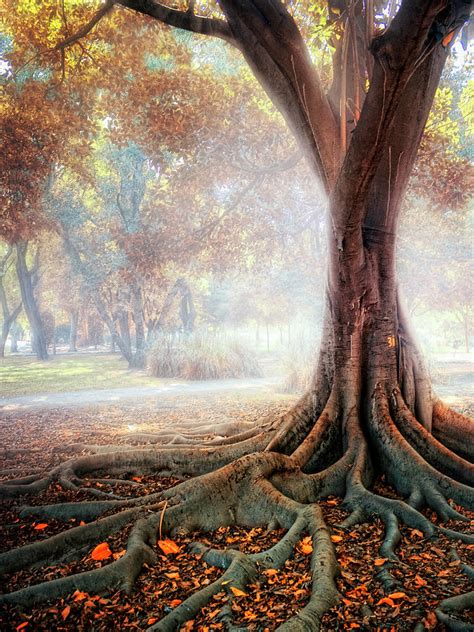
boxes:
[0,353,158,397]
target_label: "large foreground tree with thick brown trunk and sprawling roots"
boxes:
[0,0,474,630]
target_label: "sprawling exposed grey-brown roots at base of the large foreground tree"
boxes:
[0,387,474,632]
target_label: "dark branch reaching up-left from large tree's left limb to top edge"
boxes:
[116,0,237,46]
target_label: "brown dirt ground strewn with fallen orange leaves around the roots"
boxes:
[0,363,474,632]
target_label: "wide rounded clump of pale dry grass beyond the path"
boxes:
[147,333,262,380]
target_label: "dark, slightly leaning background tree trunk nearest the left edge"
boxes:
[16,242,48,360]
